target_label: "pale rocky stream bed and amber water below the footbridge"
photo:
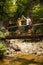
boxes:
[0,39,43,65]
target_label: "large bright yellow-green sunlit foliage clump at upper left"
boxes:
[3,0,17,16]
